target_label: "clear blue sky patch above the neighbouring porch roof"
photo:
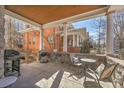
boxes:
[72,16,105,38]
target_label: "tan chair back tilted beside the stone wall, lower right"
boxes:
[99,64,118,80]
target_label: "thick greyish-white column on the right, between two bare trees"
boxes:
[106,13,114,54]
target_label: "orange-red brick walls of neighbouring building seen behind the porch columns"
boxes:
[23,28,80,53]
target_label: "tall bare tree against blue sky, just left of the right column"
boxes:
[93,17,106,54]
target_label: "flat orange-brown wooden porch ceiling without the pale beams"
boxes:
[5,5,106,24]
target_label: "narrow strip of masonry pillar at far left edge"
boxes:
[0,6,4,78]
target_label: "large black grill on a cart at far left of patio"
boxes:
[4,49,20,76]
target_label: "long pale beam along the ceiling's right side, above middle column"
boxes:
[43,7,108,28]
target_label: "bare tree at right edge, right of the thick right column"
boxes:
[113,11,124,57]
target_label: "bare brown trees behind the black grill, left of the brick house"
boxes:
[5,19,23,49]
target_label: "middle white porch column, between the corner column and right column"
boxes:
[63,23,67,52]
